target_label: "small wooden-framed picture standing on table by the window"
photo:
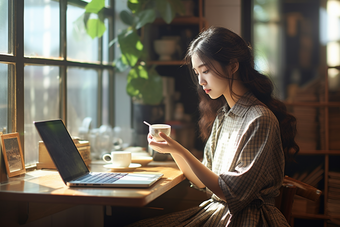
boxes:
[1,132,26,177]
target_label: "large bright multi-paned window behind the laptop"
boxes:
[0,0,114,165]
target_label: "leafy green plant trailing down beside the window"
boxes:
[77,0,185,145]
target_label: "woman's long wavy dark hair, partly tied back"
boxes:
[185,27,299,160]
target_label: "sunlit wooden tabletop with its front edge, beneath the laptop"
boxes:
[0,162,185,207]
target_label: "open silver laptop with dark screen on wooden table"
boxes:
[33,119,163,188]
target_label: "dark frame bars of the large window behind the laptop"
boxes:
[0,0,115,163]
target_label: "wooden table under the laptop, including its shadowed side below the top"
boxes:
[0,161,185,226]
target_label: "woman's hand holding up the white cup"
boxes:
[148,132,186,155]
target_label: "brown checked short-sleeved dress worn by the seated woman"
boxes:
[127,92,289,227]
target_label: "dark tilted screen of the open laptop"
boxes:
[34,120,89,183]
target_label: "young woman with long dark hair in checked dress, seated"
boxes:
[129,27,299,227]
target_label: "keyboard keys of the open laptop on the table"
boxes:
[76,173,127,184]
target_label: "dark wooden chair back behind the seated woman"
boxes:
[275,176,322,223]
